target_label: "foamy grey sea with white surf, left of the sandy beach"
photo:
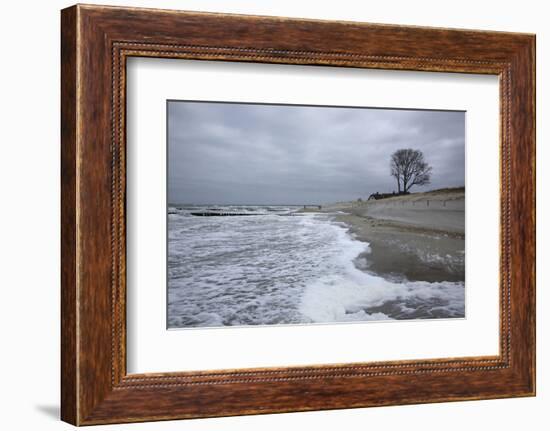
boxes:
[167,205,465,329]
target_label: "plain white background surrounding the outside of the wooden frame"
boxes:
[0,0,550,431]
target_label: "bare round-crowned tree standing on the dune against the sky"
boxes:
[390,148,432,193]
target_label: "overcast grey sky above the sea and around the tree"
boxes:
[168,101,465,205]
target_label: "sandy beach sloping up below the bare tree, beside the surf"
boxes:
[306,188,465,286]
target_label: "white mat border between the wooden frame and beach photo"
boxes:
[127,58,500,373]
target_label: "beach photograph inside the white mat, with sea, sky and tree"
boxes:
[166,100,466,329]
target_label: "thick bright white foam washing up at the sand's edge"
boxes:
[300,219,464,323]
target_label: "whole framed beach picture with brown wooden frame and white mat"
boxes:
[61,5,535,425]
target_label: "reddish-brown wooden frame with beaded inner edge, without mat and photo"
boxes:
[61,5,535,425]
